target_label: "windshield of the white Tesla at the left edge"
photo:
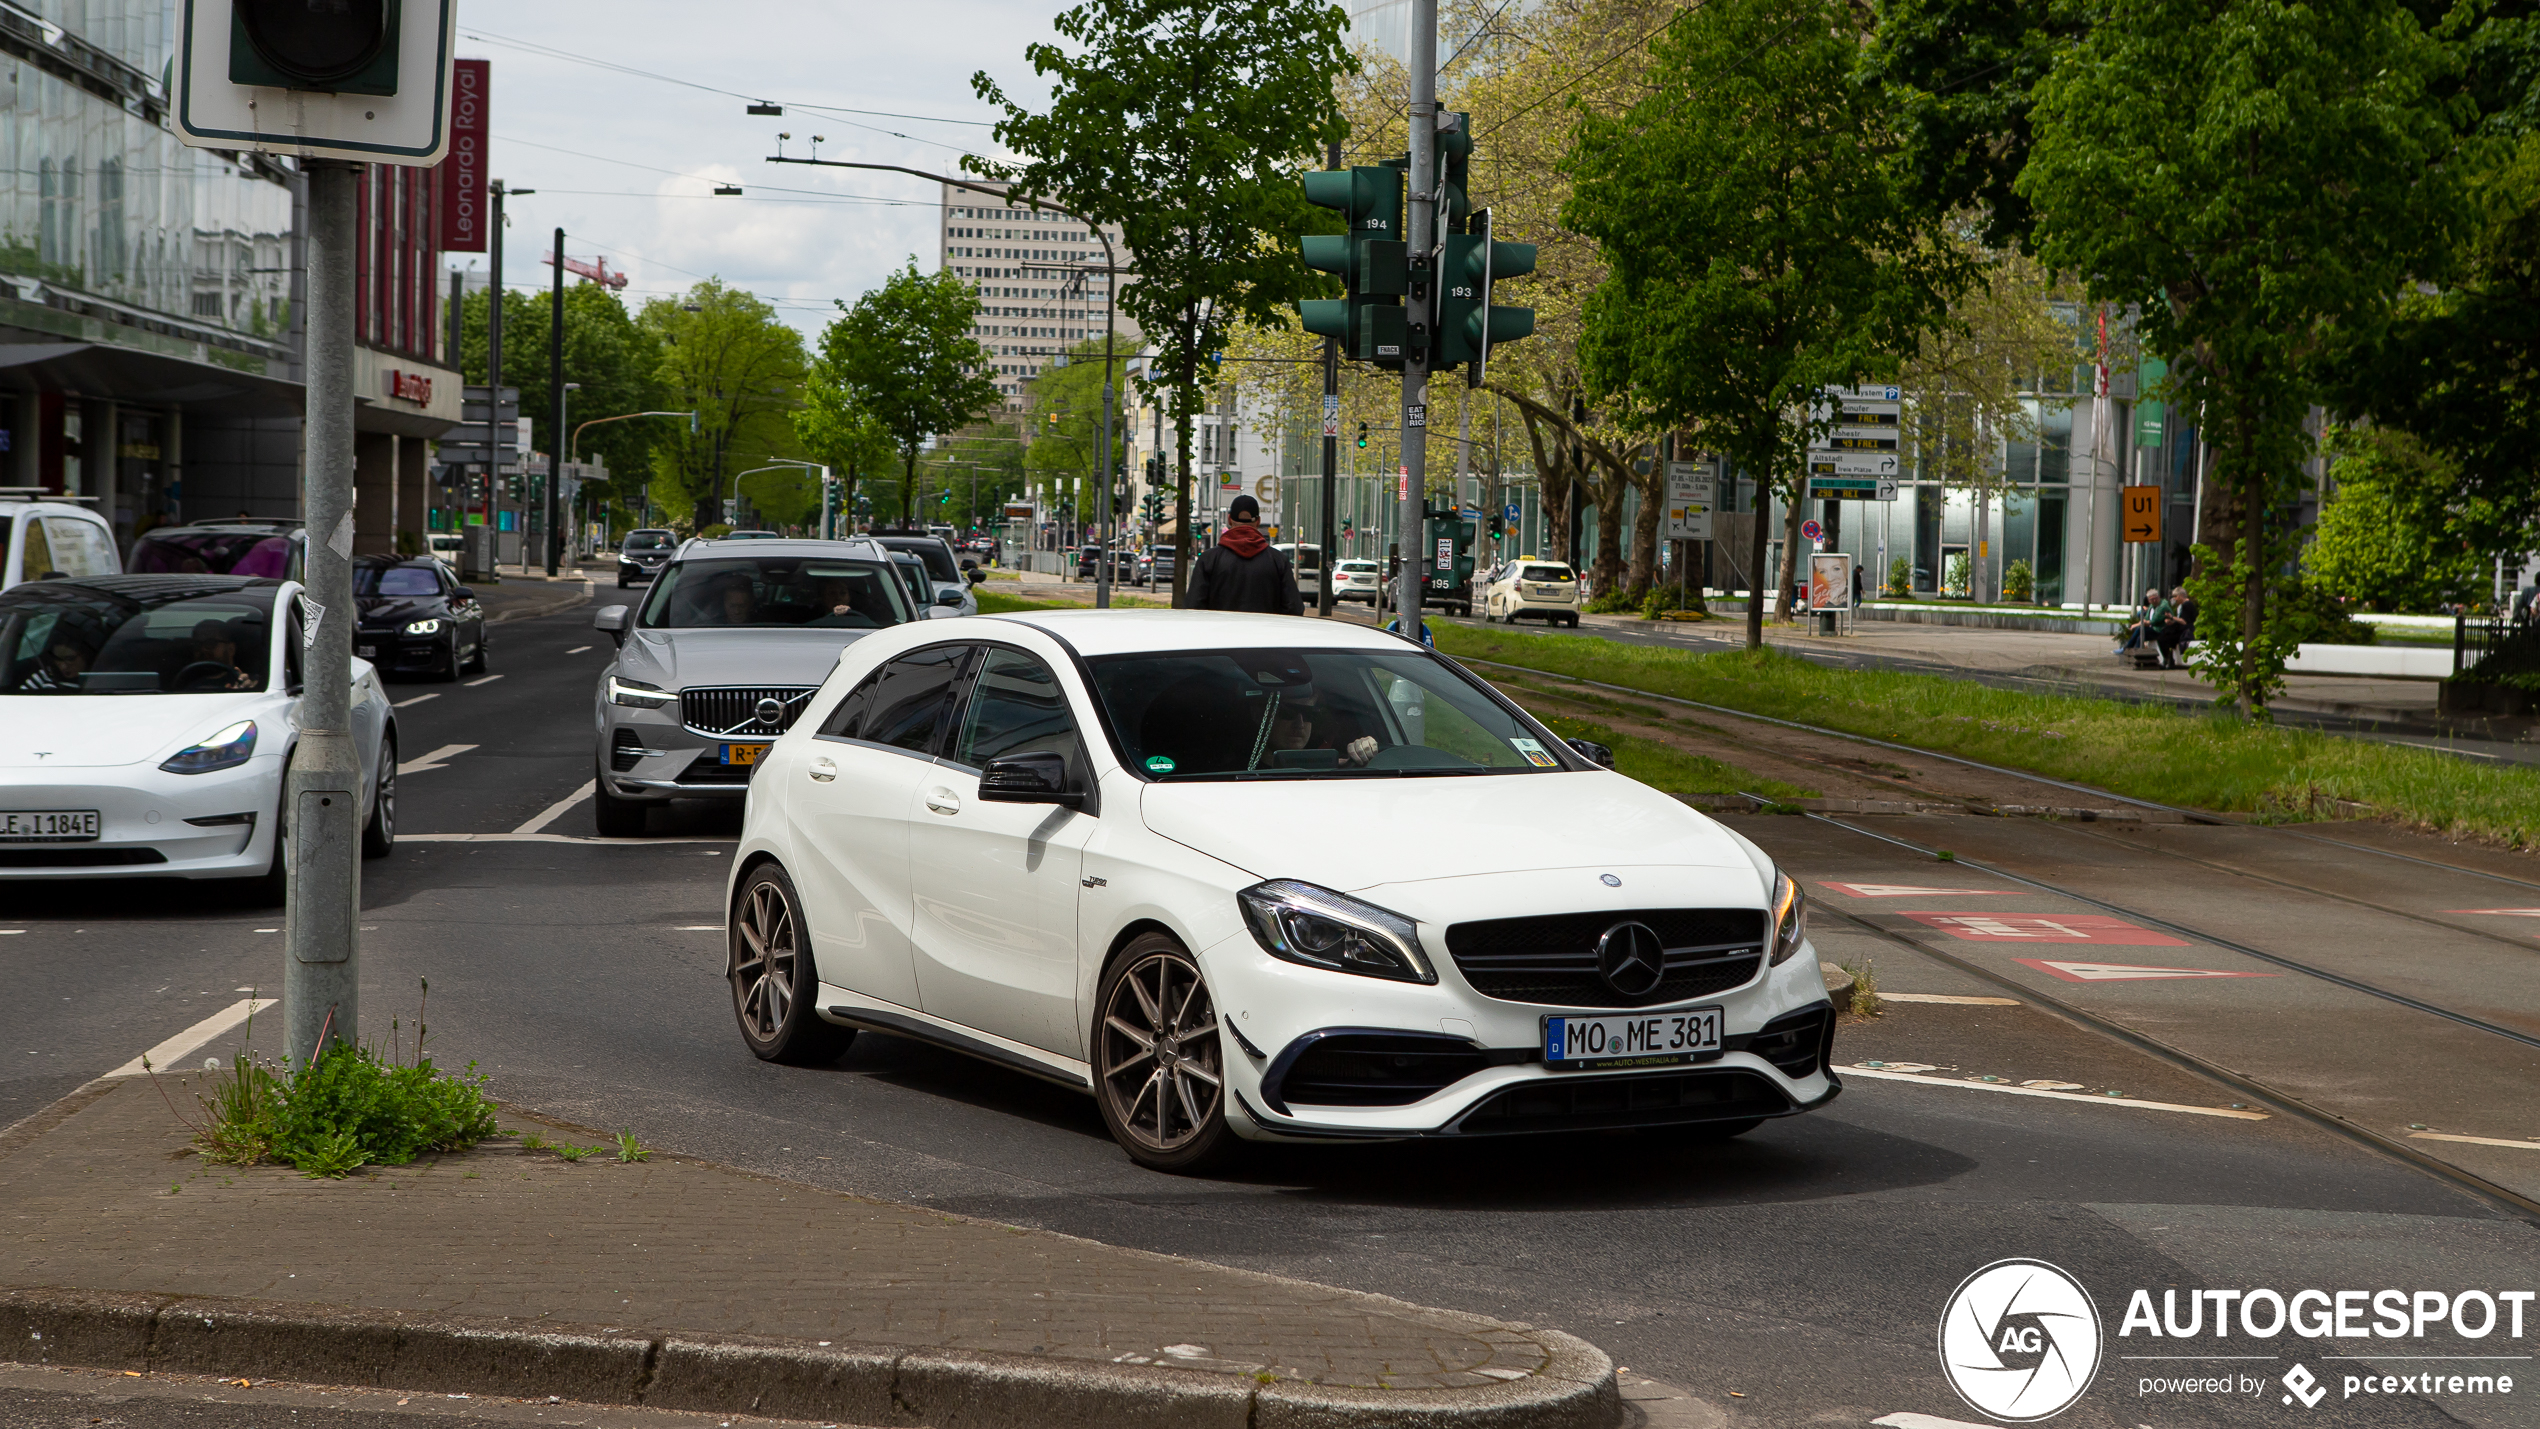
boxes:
[0,581,274,695]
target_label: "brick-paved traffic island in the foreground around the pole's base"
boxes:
[0,1076,1577,1391]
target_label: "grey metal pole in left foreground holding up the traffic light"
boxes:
[290,160,363,1066]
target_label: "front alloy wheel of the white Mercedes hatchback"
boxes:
[1095,934,1232,1170]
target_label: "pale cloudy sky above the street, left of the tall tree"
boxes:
[462,0,1059,335]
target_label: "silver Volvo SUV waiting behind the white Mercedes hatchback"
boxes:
[592,541,919,838]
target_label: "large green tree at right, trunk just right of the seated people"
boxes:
[2017,0,2461,716]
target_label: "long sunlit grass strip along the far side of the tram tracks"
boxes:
[1433,622,2540,848]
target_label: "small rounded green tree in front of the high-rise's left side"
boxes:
[813,259,998,523]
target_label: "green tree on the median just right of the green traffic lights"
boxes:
[1562,0,1963,647]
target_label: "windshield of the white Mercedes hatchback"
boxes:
[1092,650,1562,779]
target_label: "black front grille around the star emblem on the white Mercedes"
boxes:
[1445,909,1765,1008]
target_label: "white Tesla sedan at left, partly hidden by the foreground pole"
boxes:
[0,574,396,901]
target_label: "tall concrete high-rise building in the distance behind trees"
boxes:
[937,183,1138,414]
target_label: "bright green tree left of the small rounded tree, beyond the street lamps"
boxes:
[635,279,803,530]
